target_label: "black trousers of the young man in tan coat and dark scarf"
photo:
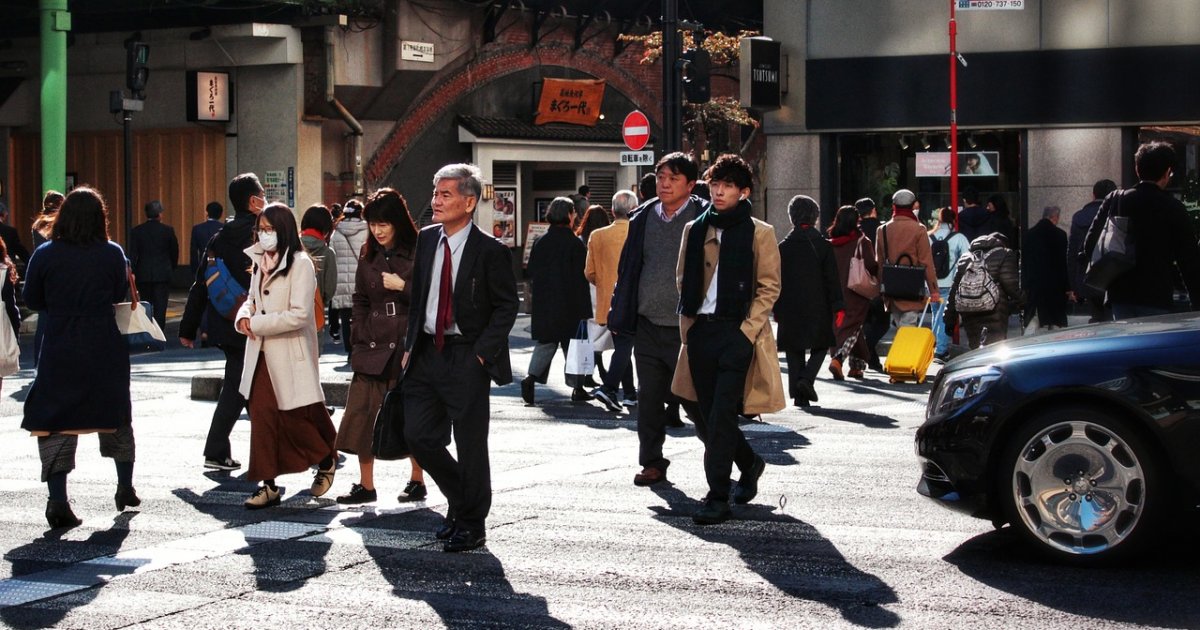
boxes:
[686,320,755,500]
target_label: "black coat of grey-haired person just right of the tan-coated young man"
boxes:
[775,227,844,352]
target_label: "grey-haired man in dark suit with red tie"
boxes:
[404,164,517,552]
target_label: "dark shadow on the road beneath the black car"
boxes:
[943,520,1200,628]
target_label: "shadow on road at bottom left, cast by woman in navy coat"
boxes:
[0,512,138,628]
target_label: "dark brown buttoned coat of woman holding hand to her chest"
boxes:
[350,244,415,376]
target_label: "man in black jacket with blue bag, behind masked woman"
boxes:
[179,173,266,470]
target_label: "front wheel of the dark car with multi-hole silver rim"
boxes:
[997,404,1166,564]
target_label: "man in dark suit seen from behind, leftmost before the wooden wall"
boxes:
[130,199,179,330]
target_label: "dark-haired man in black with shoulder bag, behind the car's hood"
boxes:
[1082,142,1200,319]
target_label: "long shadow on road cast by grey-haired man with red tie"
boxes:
[357,510,570,629]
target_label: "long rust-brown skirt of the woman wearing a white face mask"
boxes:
[246,355,337,481]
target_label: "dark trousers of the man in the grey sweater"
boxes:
[634,317,707,470]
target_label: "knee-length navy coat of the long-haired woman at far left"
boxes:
[20,241,131,432]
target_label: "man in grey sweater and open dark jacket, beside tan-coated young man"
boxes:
[608,152,709,486]
